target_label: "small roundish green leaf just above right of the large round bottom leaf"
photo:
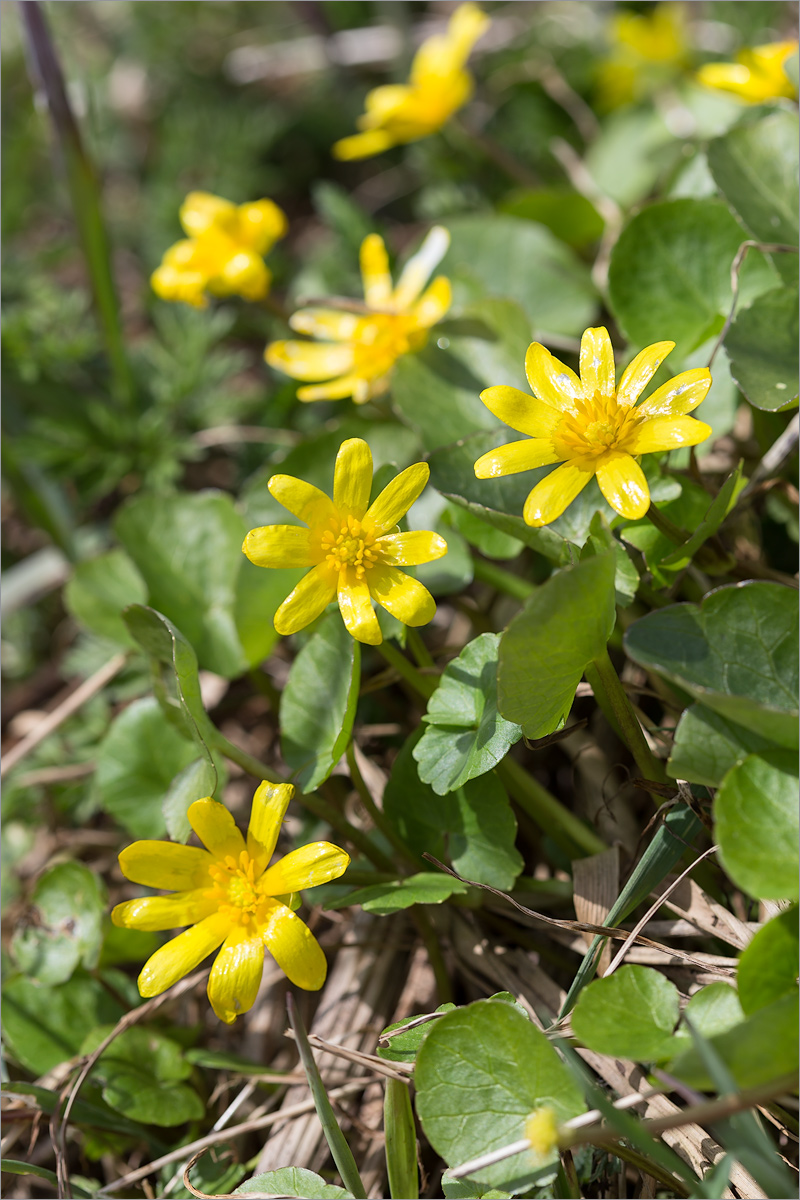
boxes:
[572,966,679,1062]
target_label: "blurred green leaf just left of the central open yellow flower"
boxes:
[114,491,247,678]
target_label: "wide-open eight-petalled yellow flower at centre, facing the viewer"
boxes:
[242,438,447,646]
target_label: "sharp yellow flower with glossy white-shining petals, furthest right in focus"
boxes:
[475,328,711,526]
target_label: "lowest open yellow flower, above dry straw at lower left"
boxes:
[112,782,350,1024]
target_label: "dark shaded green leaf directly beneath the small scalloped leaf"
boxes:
[384,728,523,890]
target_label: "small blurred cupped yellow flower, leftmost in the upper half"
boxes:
[150,192,287,308]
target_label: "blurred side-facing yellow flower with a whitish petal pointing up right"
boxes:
[264,226,451,404]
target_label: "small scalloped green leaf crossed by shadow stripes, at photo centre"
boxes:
[414,634,522,796]
